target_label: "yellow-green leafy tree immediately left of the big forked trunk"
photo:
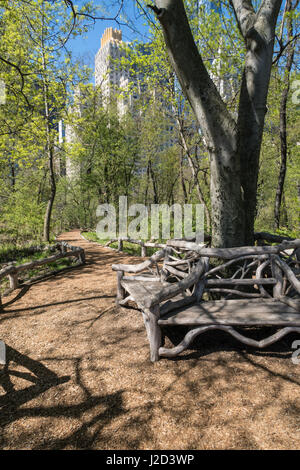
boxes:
[115,24,216,231]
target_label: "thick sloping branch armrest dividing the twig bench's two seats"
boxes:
[147,259,206,308]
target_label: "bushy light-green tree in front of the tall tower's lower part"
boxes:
[65,85,138,226]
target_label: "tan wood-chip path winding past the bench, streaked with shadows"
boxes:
[0,231,300,449]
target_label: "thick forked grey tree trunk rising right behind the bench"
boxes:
[154,0,281,247]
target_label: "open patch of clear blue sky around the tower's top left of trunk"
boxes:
[68,0,152,75]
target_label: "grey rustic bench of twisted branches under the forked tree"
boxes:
[112,240,300,361]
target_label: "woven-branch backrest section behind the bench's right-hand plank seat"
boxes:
[199,240,300,308]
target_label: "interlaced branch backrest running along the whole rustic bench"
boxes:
[112,240,300,310]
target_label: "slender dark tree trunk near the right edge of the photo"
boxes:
[274,0,295,229]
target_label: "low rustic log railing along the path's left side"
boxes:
[0,242,85,305]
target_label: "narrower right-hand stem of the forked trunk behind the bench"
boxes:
[236,0,281,245]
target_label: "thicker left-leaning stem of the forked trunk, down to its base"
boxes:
[156,0,244,247]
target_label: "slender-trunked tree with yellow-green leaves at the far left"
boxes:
[0,0,90,241]
